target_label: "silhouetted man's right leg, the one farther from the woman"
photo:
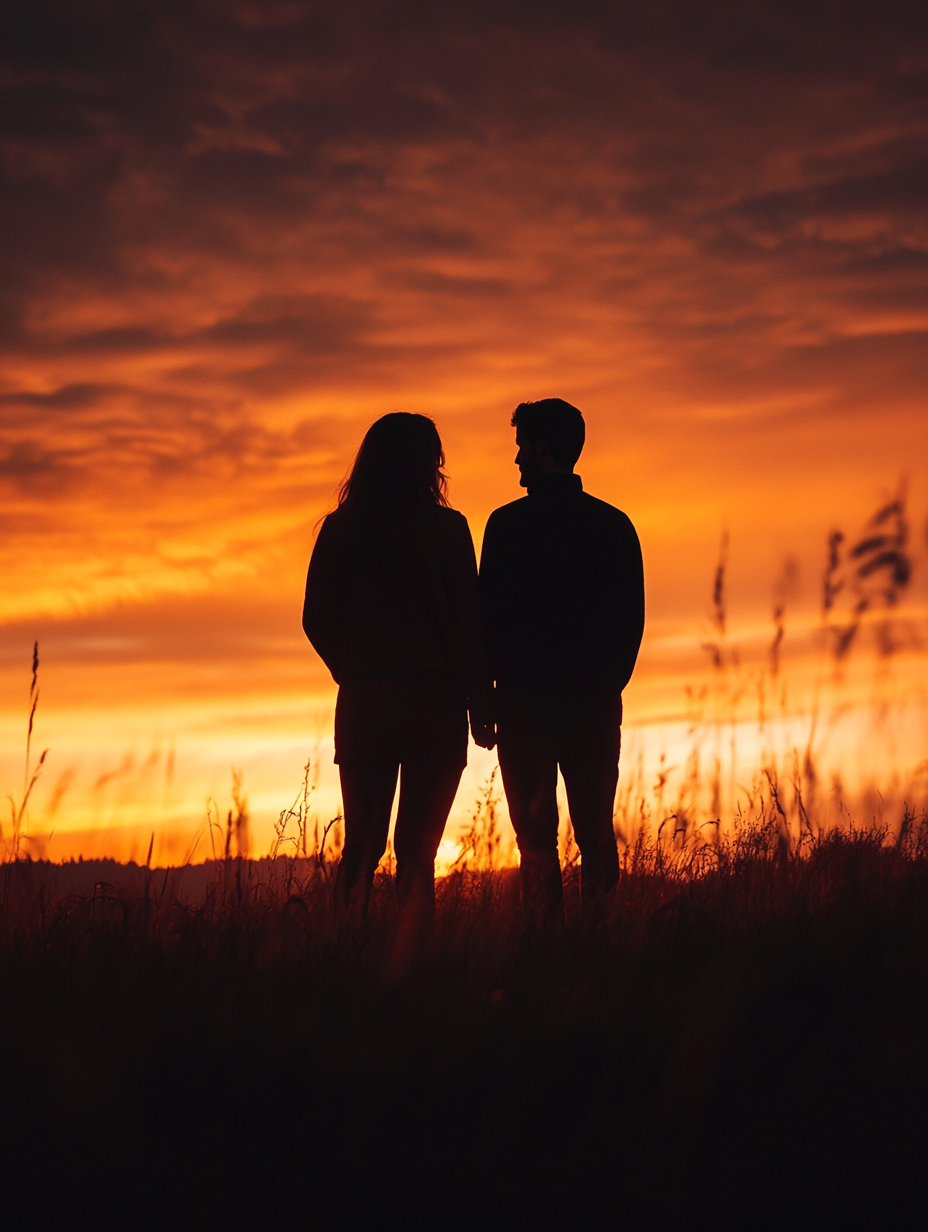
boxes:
[560,707,621,915]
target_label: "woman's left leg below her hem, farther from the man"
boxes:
[335,761,399,919]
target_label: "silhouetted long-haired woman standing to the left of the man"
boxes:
[303,413,493,924]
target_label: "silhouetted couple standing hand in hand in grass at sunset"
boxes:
[303,398,645,930]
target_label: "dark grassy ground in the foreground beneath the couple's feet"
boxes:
[0,829,928,1230]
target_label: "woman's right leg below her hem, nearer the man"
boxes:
[393,759,463,933]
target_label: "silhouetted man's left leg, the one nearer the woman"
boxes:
[497,706,563,928]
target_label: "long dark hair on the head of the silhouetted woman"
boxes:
[339,410,447,521]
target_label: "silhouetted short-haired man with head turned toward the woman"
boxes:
[481,398,645,924]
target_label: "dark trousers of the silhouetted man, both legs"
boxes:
[498,694,622,924]
